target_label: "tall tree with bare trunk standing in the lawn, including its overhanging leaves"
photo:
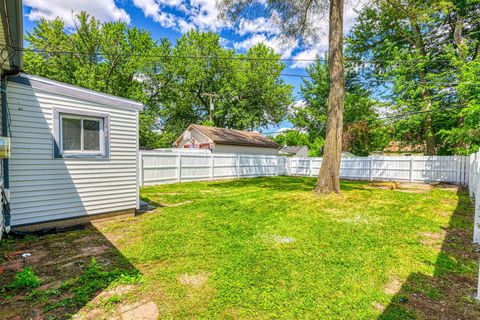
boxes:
[217,0,345,194]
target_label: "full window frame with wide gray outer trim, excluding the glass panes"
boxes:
[52,107,110,159]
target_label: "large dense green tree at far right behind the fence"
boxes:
[347,0,480,154]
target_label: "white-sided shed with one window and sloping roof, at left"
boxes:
[1,1,143,234]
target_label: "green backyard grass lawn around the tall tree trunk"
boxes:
[0,177,480,319]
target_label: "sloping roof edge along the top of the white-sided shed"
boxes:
[8,73,143,111]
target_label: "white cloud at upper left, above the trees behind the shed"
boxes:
[23,0,130,27]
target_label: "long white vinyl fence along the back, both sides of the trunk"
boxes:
[140,151,471,186]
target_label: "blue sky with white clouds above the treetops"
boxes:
[19,0,362,131]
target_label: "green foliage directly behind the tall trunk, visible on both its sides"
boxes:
[289,58,389,155]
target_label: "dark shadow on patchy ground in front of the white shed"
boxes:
[0,225,141,319]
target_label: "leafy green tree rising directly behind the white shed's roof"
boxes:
[24,12,159,147]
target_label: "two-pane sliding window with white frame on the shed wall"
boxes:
[55,113,108,158]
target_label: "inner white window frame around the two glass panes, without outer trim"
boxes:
[59,113,105,156]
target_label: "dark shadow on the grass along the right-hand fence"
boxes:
[378,190,480,320]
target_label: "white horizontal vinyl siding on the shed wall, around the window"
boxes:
[7,82,138,226]
